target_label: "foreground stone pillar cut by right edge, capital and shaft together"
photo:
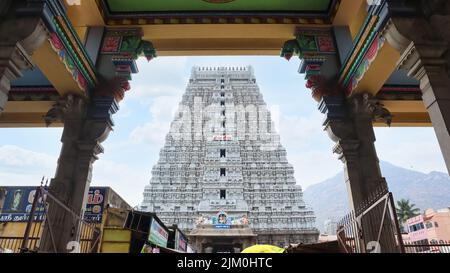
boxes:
[384,0,450,173]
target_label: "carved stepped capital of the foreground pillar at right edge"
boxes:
[384,8,450,124]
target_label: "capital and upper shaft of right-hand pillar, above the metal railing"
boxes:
[319,94,390,212]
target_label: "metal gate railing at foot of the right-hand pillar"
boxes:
[337,187,404,253]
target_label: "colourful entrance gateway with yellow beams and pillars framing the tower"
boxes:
[0,0,450,252]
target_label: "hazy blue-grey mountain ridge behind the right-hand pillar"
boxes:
[304,162,450,230]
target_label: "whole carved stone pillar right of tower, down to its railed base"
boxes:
[319,94,399,252]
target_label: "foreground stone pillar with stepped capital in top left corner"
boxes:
[0,0,48,111]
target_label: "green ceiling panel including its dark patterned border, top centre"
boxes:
[98,0,341,25]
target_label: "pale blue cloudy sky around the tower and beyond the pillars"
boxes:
[0,57,446,205]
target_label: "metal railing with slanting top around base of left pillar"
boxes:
[0,186,100,253]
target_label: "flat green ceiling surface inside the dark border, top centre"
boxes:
[106,0,331,13]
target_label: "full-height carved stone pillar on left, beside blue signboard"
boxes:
[40,95,118,253]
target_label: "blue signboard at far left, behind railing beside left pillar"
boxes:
[0,187,44,222]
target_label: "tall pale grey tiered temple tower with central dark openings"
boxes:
[141,66,318,245]
